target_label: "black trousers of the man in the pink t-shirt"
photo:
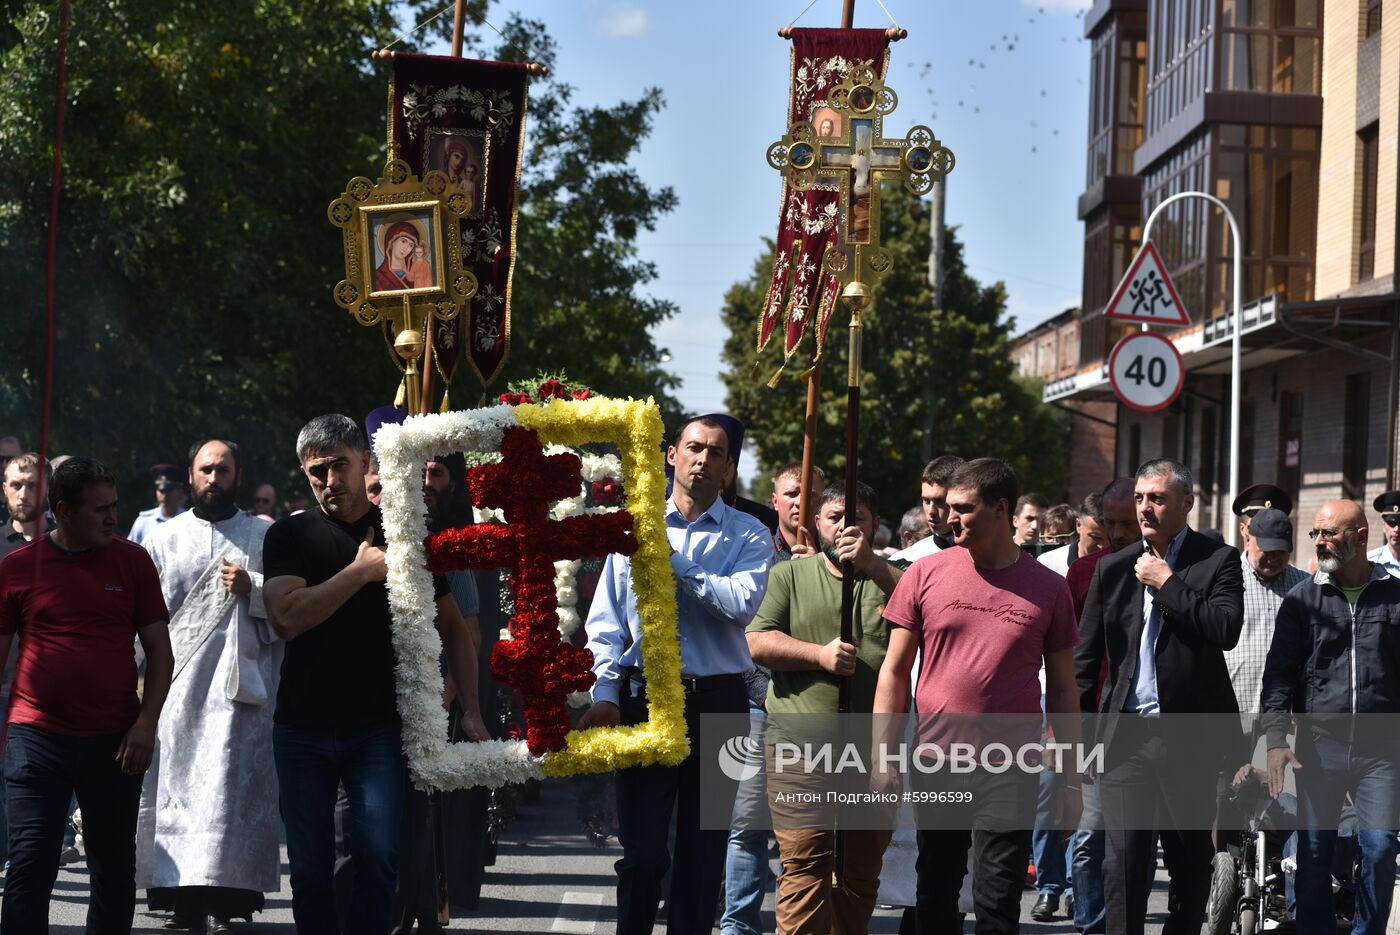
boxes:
[914,770,1039,935]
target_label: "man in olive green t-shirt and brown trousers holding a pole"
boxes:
[748,484,902,935]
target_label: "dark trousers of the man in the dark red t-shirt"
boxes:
[0,724,141,935]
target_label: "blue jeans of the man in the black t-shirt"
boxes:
[273,724,405,935]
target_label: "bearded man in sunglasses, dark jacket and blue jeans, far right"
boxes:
[1260,500,1400,935]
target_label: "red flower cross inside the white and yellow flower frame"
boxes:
[424,428,637,756]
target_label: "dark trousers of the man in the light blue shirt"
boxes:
[615,675,749,935]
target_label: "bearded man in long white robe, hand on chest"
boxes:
[137,438,284,935]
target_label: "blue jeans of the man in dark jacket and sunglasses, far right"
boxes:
[1295,731,1400,935]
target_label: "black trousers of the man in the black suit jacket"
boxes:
[1100,714,1218,935]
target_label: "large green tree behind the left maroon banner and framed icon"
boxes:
[0,0,679,523]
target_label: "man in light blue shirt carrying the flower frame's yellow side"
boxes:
[578,417,773,935]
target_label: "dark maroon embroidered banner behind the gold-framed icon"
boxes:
[389,52,528,386]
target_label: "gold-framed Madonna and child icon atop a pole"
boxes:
[326,160,477,413]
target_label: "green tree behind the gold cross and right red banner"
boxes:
[724,185,1068,521]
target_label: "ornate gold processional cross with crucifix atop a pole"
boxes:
[767,66,956,308]
